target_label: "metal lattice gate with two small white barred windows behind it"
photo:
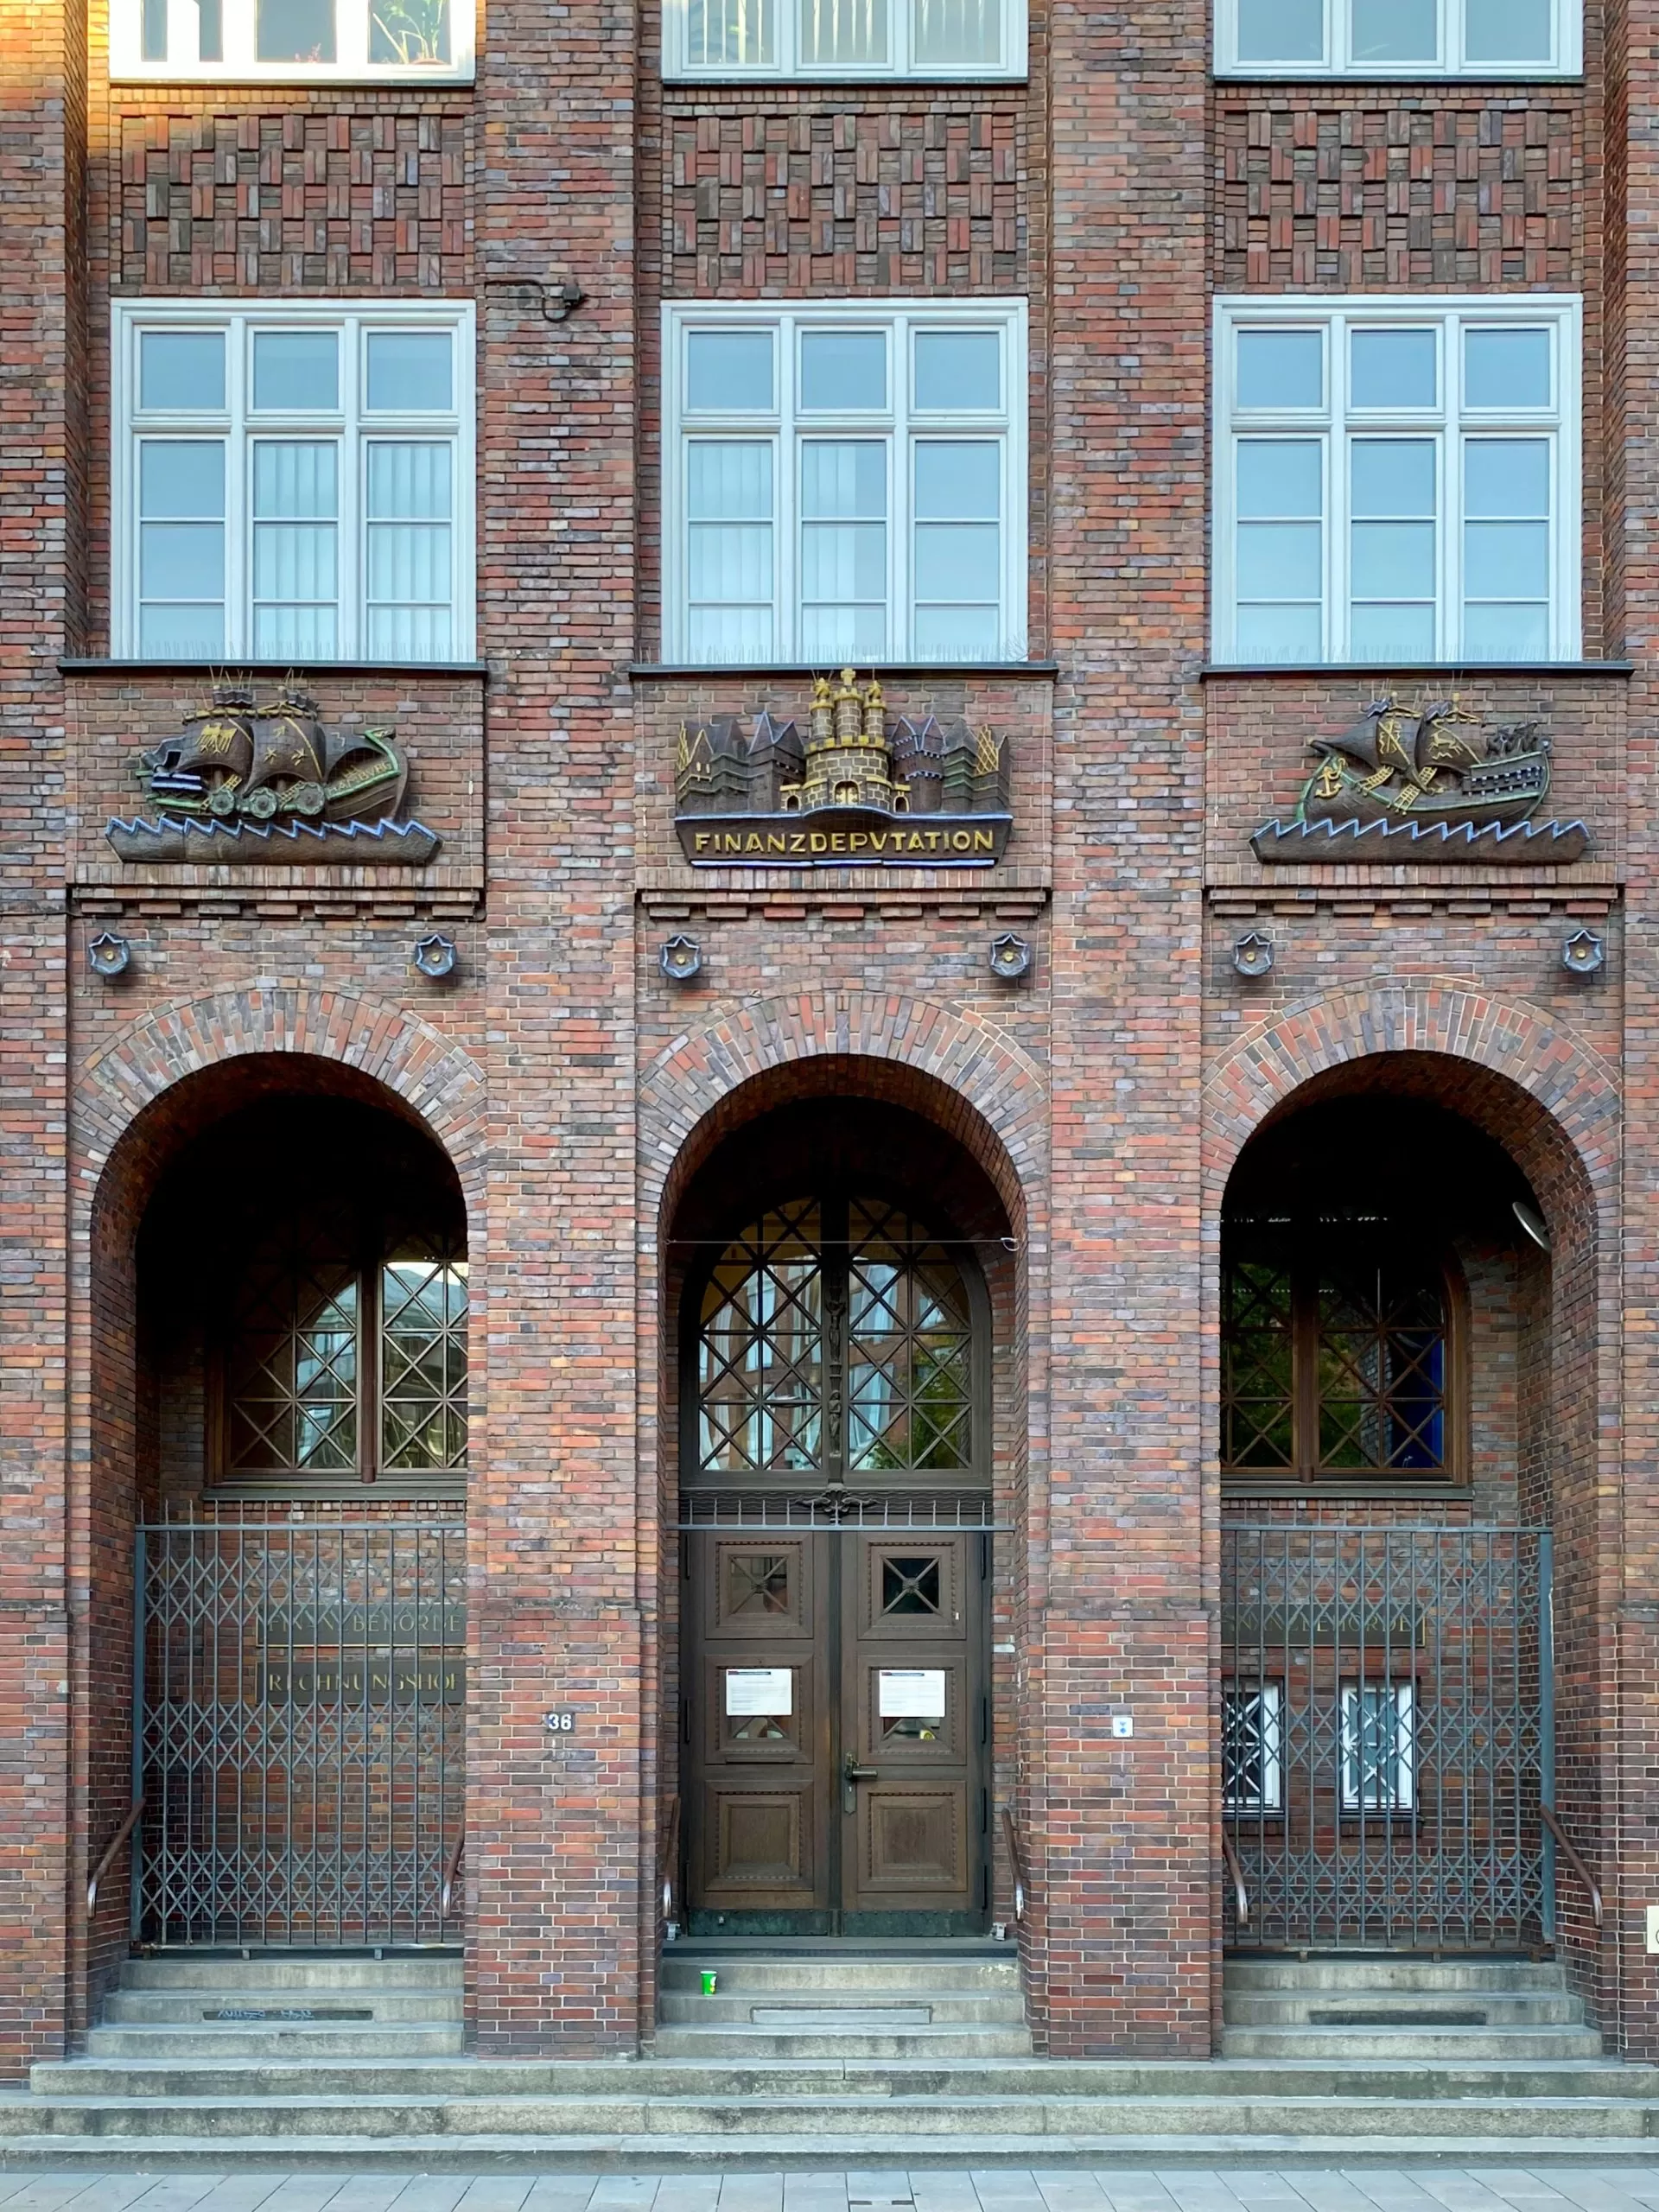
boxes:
[1221,1524,1553,1948]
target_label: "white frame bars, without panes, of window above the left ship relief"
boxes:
[111,299,478,666]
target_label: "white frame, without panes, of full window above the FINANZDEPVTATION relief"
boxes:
[661,299,1028,668]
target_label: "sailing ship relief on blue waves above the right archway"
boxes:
[1249,696,1591,865]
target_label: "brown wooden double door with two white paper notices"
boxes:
[681,1529,991,1936]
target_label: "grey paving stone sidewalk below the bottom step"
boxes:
[0,2159,1659,2212]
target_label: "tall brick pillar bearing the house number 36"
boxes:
[469,0,641,2055]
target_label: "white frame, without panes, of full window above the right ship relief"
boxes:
[1210,292,1584,668]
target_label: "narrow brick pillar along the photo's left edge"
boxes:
[0,0,86,2079]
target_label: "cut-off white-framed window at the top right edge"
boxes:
[1214,0,1584,78]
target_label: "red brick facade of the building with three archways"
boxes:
[0,0,1659,2079]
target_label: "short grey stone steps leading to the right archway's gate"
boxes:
[1221,1958,1601,2063]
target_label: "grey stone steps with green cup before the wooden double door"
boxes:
[657,1942,1031,2062]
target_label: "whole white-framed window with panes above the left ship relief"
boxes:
[111,301,474,666]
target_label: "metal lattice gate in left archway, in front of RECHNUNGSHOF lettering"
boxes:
[133,1520,467,1948]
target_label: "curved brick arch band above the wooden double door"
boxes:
[639,991,1048,1228]
